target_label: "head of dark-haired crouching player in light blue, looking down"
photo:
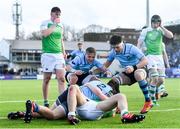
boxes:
[109,35,123,52]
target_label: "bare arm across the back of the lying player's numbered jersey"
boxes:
[85,83,108,100]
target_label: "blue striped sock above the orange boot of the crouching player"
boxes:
[138,80,151,102]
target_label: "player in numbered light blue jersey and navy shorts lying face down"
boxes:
[8,75,120,121]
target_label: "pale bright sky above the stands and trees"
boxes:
[0,0,180,39]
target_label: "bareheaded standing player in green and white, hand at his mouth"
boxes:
[40,7,66,107]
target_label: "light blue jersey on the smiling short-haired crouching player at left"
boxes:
[69,54,103,73]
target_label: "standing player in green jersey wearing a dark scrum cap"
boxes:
[138,15,173,105]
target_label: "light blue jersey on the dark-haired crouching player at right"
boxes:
[107,43,144,67]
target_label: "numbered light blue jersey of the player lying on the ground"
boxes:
[80,80,112,101]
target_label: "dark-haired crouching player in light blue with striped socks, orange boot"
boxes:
[104,36,152,114]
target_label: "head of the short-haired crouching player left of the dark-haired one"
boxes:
[86,47,96,62]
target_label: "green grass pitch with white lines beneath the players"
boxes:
[0,79,180,128]
